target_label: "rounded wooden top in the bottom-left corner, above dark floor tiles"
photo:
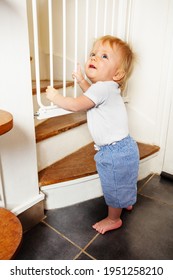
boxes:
[0,208,22,260]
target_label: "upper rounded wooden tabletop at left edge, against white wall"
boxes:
[0,110,13,135]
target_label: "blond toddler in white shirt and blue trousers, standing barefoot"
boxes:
[46,35,139,234]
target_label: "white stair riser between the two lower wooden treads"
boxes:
[37,124,92,171]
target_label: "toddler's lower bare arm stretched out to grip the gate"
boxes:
[46,86,95,112]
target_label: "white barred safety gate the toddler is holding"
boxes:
[32,0,133,119]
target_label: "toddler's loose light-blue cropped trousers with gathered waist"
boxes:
[94,136,139,208]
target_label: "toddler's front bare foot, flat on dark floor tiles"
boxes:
[92,217,122,234]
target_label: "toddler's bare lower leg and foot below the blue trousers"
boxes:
[93,206,122,234]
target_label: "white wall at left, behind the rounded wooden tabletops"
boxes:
[0,0,43,212]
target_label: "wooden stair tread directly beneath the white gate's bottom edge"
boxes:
[35,112,87,142]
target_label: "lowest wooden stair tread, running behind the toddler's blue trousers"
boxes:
[39,143,159,186]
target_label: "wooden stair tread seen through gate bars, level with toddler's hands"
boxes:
[32,80,74,94]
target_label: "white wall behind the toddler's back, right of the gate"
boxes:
[125,0,173,173]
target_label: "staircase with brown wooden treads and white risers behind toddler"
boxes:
[33,81,159,209]
